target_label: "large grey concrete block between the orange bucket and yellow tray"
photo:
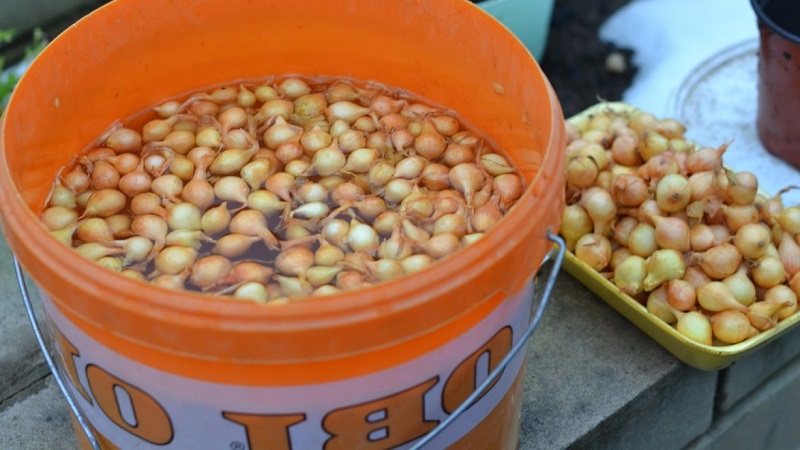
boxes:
[519,273,717,450]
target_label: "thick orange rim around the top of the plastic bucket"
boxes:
[0,0,565,329]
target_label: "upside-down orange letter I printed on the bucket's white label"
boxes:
[222,412,306,450]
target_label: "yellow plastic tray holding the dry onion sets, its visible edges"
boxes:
[563,102,800,370]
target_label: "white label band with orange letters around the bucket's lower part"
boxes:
[40,283,533,450]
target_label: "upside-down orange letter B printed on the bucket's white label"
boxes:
[322,377,439,450]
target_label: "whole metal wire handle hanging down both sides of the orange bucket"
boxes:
[12,231,566,450]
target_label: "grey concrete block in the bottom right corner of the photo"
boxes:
[687,358,800,450]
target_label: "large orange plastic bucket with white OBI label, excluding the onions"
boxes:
[0,0,564,450]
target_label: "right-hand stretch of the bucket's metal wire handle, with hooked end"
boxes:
[409,230,567,450]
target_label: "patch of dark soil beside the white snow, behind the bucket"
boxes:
[540,0,636,117]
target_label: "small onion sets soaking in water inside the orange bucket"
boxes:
[40,76,524,303]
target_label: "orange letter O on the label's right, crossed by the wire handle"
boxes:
[442,327,511,414]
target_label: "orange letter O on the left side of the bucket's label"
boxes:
[86,364,173,445]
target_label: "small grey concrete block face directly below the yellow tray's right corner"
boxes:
[717,322,800,411]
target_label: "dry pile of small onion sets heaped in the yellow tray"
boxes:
[560,105,800,345]
